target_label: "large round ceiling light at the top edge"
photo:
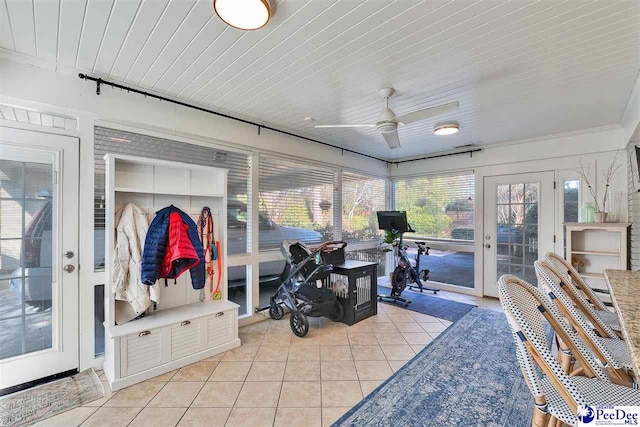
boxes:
[213,0,272,30]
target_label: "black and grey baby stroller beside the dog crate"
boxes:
[269,240,347,337]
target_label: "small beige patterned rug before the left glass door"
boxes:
[0,369,104,427]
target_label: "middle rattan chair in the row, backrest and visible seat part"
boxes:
[534,261,636,388]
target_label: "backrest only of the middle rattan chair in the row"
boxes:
[533,261,623,369]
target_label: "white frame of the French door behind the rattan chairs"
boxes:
[476,171,556,297]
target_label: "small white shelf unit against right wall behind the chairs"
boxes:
[564,222,630,302]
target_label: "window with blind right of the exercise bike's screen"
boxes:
[394,173,475,240]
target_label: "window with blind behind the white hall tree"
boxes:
[94,126,250,271]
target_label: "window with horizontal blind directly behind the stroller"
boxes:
[258,154,337,251]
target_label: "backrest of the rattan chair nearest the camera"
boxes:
[498,275,596,413]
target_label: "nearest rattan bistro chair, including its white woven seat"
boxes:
[498,275,640,427]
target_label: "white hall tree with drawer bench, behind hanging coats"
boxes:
[104,154,240,390]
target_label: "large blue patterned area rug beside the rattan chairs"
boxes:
[333,308,533,427]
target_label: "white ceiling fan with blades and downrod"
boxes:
[315,87,459,148]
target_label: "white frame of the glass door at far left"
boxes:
[0,127,80,389]
